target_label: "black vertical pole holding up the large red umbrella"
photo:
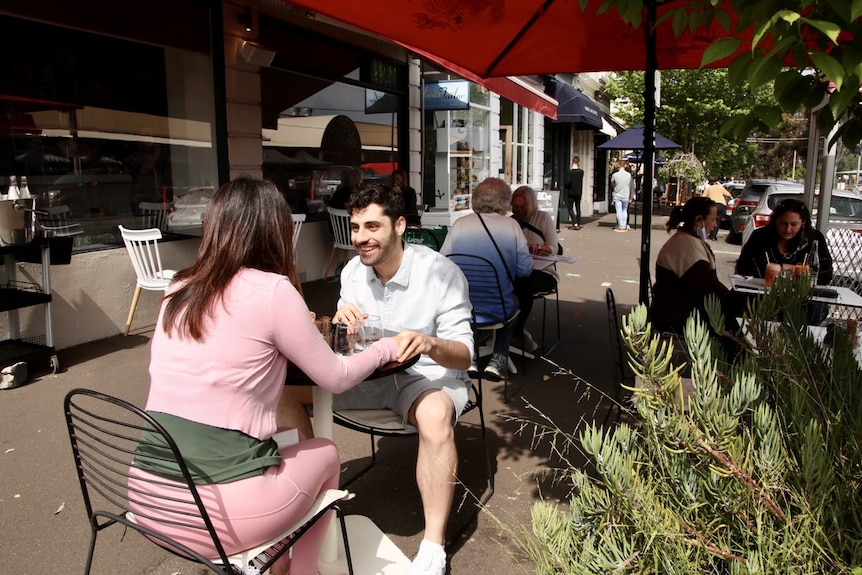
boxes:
[639,0,658,306]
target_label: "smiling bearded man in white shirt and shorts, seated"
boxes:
[285,184,473,575]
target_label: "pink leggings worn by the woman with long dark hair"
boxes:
[129,438,340,575]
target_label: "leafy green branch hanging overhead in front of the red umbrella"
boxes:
[600,0,862,149]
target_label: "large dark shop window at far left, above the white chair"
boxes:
[0,14,218,251]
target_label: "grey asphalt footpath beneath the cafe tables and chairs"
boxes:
[0,214,738,575]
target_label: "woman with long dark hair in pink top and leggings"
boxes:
[130,178,408,575]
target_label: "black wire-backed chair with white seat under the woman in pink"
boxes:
[63,389,353,575]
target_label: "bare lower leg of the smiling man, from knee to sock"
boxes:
[410,390,458,545]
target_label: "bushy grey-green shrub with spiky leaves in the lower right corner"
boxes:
[506,278,862,575]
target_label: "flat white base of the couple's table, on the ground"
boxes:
[317,515,411,575]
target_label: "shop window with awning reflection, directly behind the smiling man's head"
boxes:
[260,17,406,220]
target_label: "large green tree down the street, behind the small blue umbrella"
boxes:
[607,70,756,177]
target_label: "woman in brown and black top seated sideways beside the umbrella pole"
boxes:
[650,197,729,333]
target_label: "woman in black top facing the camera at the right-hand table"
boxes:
[736,200,832,285]
